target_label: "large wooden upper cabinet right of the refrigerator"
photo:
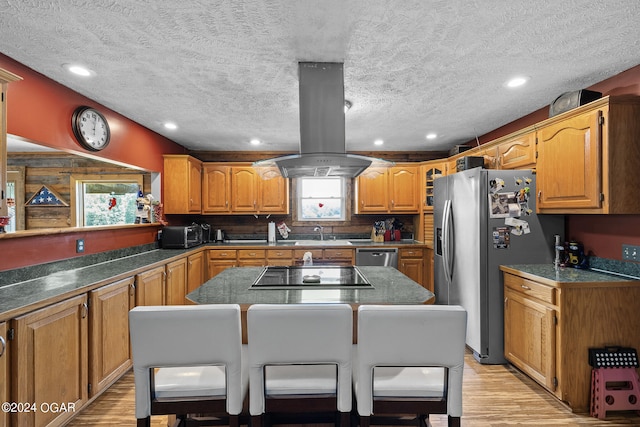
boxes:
[537,96,640,214]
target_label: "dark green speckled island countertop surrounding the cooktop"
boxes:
[187,266,434,305]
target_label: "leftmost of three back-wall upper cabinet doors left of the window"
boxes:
[202,163,231,214]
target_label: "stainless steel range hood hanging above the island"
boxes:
[253,62,393,178]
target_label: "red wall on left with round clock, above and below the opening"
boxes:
[0,54,187,271]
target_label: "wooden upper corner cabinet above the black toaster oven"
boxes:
[162,154,202,214]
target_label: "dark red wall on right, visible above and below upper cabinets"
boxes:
[468,65,640,260]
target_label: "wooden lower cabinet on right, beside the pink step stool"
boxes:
[501,266,640,412]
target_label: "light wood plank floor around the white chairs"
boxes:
[68,354,640,427]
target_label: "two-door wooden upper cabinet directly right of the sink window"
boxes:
[355,164,421,214]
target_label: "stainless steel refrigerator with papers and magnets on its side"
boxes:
[434,168,564,364]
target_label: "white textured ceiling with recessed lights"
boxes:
[0,0,640,151]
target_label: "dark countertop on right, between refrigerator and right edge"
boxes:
[500,264,640,285]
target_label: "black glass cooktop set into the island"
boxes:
[251,265,373,289]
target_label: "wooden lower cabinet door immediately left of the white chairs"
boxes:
[89,277,135,397]
